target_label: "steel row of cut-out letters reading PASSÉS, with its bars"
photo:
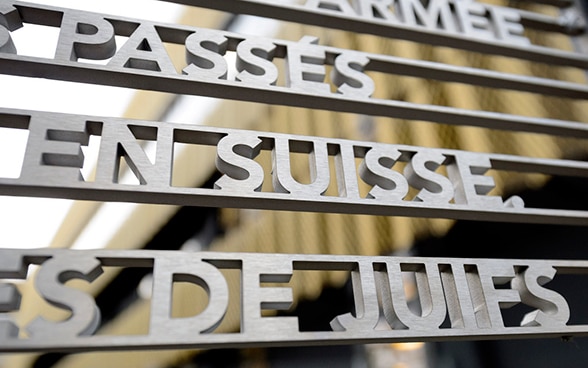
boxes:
[0,2,588,138]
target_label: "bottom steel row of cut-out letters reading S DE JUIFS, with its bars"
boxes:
[0,249,588,352]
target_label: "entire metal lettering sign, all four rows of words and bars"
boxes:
[0,0,588,353]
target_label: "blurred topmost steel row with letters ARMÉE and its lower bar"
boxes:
[157,0,586,68]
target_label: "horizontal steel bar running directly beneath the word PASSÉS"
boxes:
[0,54,588,138]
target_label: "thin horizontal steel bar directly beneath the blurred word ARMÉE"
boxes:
[155,0,588,69]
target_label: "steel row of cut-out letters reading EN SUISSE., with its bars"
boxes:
[0,109,588,225]
